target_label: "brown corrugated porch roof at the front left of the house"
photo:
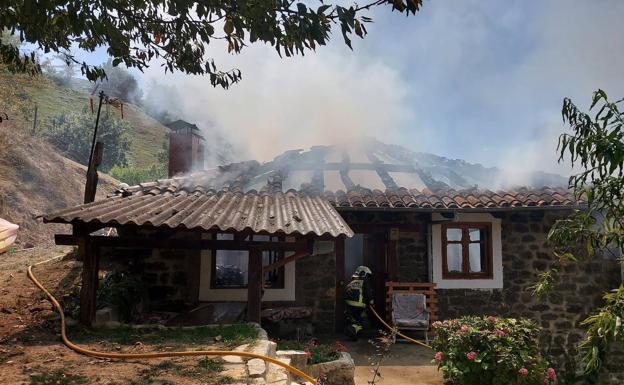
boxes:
[44,188,353,237]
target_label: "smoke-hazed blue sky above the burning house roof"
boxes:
[72,0,624,172]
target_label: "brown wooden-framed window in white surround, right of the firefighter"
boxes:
[442,223,492,279]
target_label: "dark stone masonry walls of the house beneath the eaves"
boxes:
[114,202,622,383]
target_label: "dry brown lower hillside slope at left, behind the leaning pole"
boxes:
[0,121,119,248]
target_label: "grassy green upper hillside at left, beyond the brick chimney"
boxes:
[0,68,168,167]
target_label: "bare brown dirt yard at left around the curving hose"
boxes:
[0,247,254,385]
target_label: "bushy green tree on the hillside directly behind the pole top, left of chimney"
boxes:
[41,106,130,172]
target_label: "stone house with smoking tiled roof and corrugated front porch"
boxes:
[45,133,621,372]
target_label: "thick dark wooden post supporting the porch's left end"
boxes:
[78,235,100,326]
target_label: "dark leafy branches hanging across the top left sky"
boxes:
[0,0,422,88]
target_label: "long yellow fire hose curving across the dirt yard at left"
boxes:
[27,255,317,385]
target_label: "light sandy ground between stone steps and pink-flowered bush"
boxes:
[345,340,442,385]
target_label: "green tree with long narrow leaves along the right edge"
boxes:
[536,90,624,375]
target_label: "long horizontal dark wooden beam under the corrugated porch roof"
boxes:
[54,234,310,252]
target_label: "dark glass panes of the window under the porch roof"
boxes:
[211,233,284,289]
